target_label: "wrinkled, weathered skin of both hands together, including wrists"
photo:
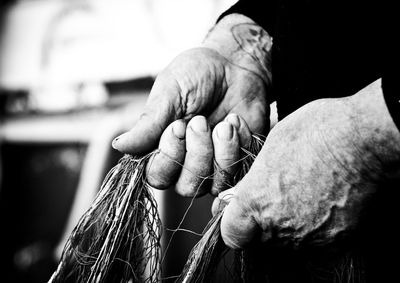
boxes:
[113,14,400,252]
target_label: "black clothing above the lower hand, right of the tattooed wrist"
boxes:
[221,0,400,126]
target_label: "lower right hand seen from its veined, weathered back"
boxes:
[219,81,400,248]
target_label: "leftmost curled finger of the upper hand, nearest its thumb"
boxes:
[146,120,186,189]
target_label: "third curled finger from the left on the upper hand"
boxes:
[211,121,240,195]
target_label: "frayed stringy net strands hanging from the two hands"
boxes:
[49,136,262,283]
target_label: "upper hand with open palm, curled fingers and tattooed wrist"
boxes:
[113,15,271,196]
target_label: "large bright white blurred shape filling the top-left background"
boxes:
[0,0,234,90]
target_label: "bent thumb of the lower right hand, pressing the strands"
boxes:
[221,182,259,249]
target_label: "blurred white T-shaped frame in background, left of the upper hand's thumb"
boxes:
[0,92,155,265]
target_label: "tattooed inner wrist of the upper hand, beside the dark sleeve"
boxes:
[202,14,272,85]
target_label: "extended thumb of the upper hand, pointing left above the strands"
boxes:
[112,75,180,154]
